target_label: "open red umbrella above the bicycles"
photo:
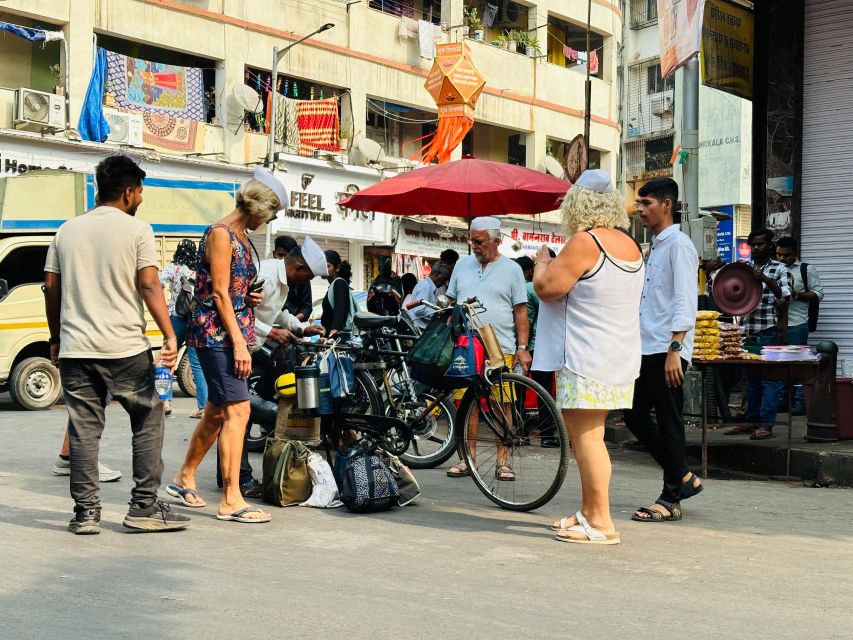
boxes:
[341,158,572,218]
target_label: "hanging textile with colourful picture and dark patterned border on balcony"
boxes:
[107,51,206,122]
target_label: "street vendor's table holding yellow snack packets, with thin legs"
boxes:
[693,354,824,478]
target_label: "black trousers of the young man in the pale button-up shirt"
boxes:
[625,353,688,502]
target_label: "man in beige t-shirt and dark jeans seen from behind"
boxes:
[44,155,190,535]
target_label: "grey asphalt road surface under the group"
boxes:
[0,396,853,640]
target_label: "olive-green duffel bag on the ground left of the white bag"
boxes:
[261,438,312,507]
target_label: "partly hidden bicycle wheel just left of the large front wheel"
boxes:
[394,391,456,469]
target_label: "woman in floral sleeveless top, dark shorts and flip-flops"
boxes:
[166,168,287,523]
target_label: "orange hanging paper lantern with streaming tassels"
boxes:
[419,42,486,162]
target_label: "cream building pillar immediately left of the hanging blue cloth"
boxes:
[62,2,95,129]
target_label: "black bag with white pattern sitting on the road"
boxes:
[341,448,400,513]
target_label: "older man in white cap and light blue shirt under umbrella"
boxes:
[447,216,532,482]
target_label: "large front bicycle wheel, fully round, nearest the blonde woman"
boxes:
[457,373,569,511]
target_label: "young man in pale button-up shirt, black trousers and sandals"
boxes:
[625,178,702,522]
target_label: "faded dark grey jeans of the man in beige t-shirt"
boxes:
[59,351,165,512]
